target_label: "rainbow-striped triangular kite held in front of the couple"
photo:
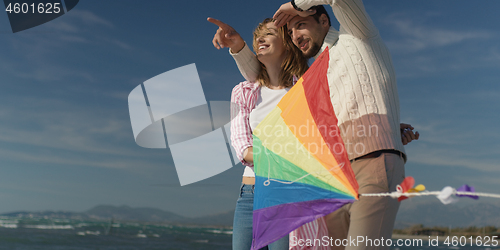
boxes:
[252,49,358,249]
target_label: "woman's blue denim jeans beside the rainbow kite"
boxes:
[233,184,288,250]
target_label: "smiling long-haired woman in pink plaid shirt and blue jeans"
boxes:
[209,18,316,250]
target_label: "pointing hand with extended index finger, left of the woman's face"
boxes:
[207,17,245,53]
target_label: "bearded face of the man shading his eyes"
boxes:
[287,16,326,58]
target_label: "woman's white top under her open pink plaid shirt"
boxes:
[243,86,290,177]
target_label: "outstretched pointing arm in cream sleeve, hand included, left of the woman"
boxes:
[207,17,260,82]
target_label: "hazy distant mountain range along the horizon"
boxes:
[6,198,500,229]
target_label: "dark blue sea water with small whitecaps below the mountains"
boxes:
[0,218,500,250]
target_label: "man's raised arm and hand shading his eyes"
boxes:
[274,0,378,39]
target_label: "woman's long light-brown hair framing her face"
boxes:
[253,18,309,88]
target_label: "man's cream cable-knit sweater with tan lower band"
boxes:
[233,0,405,159]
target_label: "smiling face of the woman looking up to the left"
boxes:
[254,22,285,64]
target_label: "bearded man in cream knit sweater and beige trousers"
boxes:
[210,0,418,249]
